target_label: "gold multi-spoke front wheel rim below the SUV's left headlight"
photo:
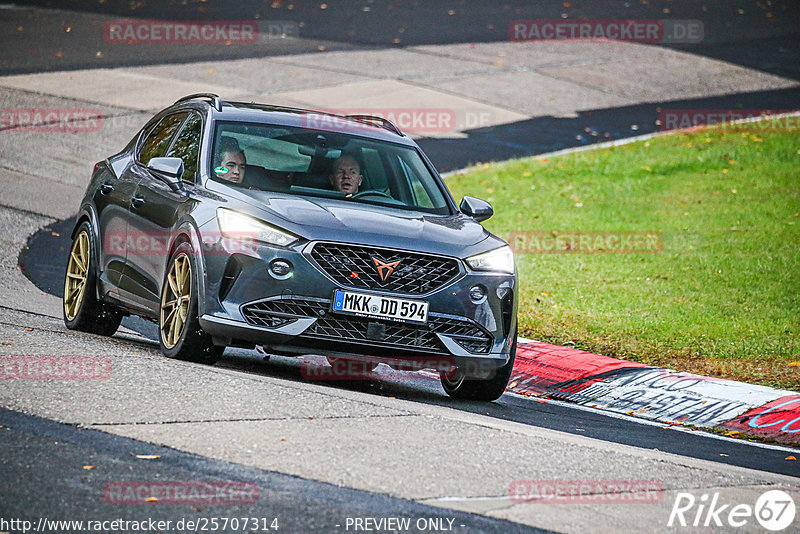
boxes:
[159,254,192,349]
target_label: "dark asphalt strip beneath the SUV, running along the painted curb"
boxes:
[19,219,800,476]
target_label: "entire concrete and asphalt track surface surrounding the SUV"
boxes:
[0,0,800,532]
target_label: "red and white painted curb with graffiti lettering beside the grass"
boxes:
[508,338,800,445]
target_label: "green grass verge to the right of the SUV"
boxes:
[447,120,800,390]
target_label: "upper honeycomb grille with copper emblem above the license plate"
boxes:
[311,243,461,295]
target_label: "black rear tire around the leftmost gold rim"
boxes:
[61,221,122,336]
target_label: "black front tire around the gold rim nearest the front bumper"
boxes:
[158,242,225,365]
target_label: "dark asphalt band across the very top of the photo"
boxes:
[0,0,800,79]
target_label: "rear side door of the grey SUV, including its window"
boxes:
[114,111,189,312]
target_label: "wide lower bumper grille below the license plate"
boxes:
[242,298,492,354]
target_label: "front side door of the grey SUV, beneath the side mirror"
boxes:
[127,112,203,313]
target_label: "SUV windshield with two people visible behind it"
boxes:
[210,119,450,215]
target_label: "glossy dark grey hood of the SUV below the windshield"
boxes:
[228,191,501,256]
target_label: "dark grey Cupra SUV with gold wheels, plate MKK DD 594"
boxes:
[64,94,518,400]
